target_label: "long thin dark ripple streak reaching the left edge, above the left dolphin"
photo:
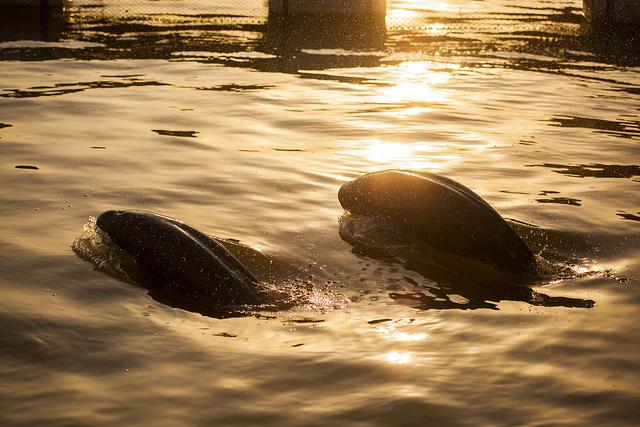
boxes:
[0,80,167,98]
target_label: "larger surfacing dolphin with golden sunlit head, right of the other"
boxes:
[338,170,537,276]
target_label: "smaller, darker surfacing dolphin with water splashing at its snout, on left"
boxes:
[97,211,259,314]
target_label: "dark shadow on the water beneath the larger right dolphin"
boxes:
[340,217,595,310]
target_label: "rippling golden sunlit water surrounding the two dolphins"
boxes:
[0,1,640,426]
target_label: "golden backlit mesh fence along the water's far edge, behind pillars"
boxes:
[66,0,582,30]
